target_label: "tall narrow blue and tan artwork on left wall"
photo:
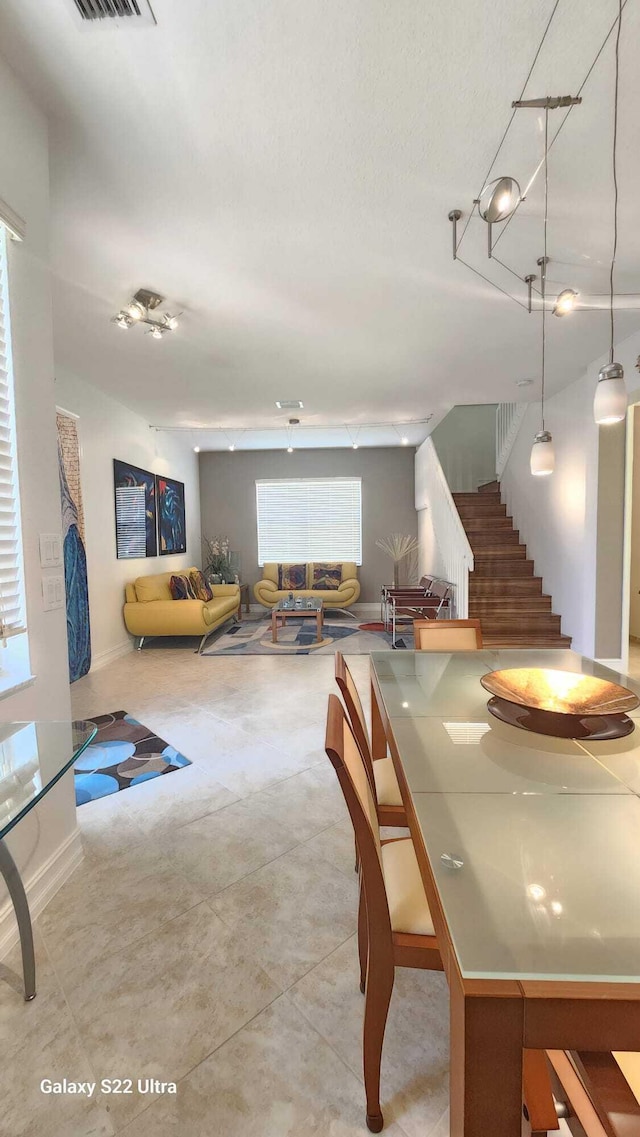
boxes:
[56,412,91,683]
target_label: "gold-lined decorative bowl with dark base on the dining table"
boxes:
[480,667,640,739]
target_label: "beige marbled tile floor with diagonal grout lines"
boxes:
[0,644,449,1137]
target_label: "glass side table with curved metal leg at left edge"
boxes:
[0,722,97,1002]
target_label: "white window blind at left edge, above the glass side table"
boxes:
[0,224,25,639]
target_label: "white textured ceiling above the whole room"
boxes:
[0,0,640,446]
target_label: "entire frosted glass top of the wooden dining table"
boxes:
[372,650,640,982]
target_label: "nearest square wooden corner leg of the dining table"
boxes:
[450,965,524,1137]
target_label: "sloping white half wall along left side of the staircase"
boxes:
[416,438,473,620]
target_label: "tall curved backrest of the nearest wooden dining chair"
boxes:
[325,695,392,952]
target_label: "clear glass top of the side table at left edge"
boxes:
[0,722,95,839]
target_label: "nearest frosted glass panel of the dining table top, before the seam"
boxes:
[413,794,640,982]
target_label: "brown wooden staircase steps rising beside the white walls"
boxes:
[454,482,571,648]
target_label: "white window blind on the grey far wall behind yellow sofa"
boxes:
[256,478,363,565]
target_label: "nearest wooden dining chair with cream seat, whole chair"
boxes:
[325,695,442,1134]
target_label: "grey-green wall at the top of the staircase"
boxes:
[431,402,497,493]
